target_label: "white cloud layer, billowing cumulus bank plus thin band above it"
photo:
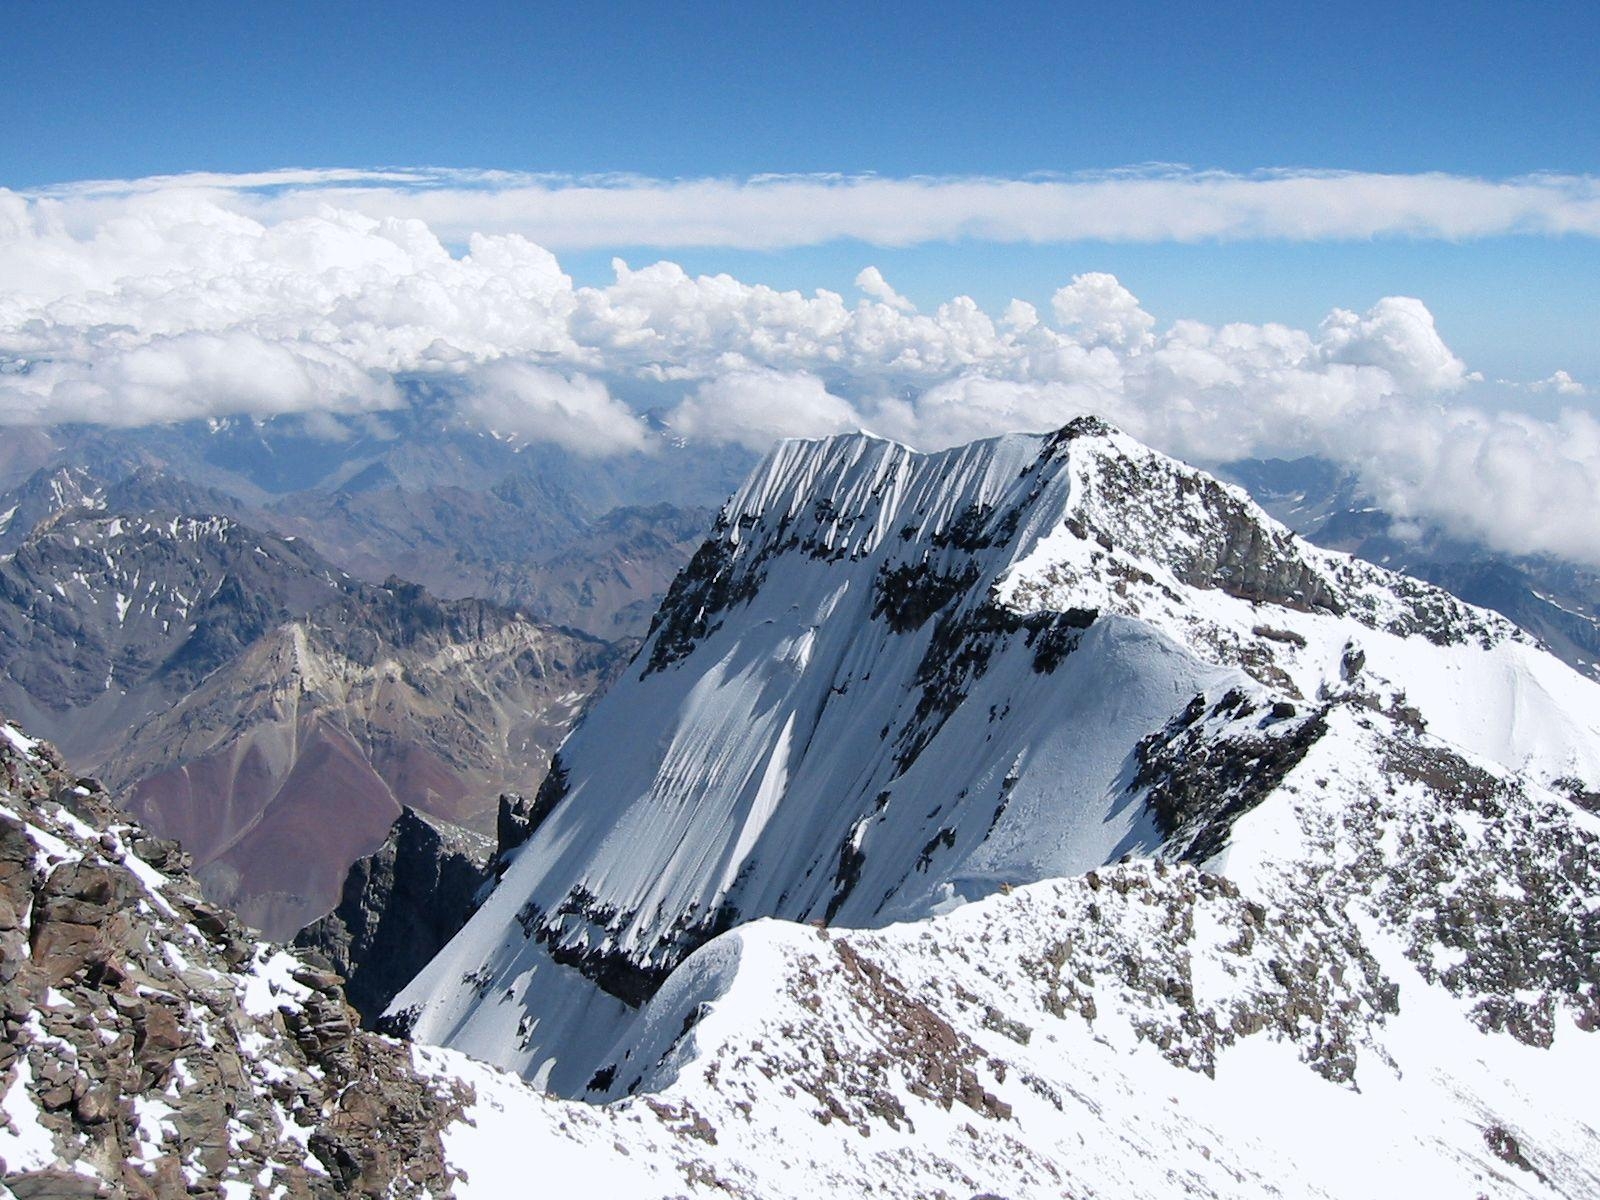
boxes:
[0,173,1600,562]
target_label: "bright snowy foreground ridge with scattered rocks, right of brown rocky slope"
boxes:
[418,693,1600,1200]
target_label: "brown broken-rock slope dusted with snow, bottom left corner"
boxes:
[0,722,466,1198]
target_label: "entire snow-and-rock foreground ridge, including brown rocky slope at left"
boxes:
[0,694,1600,1200]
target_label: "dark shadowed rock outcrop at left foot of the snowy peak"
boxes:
[294,812,489,1029]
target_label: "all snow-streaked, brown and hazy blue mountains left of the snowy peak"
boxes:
[0,400,752,938]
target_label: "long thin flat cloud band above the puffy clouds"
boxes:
[15,168,1600,250]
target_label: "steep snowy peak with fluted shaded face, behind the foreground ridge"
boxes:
[392,419,1600,1098]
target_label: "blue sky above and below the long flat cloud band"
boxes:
[12,3,1600,385]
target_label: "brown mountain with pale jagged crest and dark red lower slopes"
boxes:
[104,584,627,938]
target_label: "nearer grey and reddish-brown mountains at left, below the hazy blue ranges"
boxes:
[0,502,630,938]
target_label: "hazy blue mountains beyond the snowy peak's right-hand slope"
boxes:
[1219,458,1600,678]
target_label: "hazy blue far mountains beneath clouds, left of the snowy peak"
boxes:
[0,395,750,638]
